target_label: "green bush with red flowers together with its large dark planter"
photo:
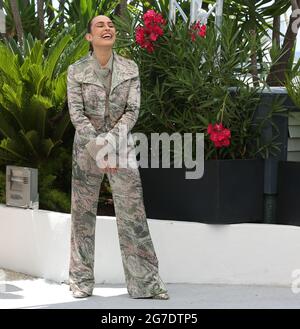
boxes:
[112,10,282,223]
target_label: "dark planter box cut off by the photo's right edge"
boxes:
[276,161,300,226]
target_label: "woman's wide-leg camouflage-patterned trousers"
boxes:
[69,144,167,298]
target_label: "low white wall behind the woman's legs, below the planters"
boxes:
[0,204,300,286]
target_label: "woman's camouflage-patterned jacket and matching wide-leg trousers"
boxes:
[67,50,167,298]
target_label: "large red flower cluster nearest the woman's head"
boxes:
[135,9,167,52]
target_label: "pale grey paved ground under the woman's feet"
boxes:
[0,269,300,309]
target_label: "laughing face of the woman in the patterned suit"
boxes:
[86,15,116,49]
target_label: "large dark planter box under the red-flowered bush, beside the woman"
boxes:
[139,159,264,224]
